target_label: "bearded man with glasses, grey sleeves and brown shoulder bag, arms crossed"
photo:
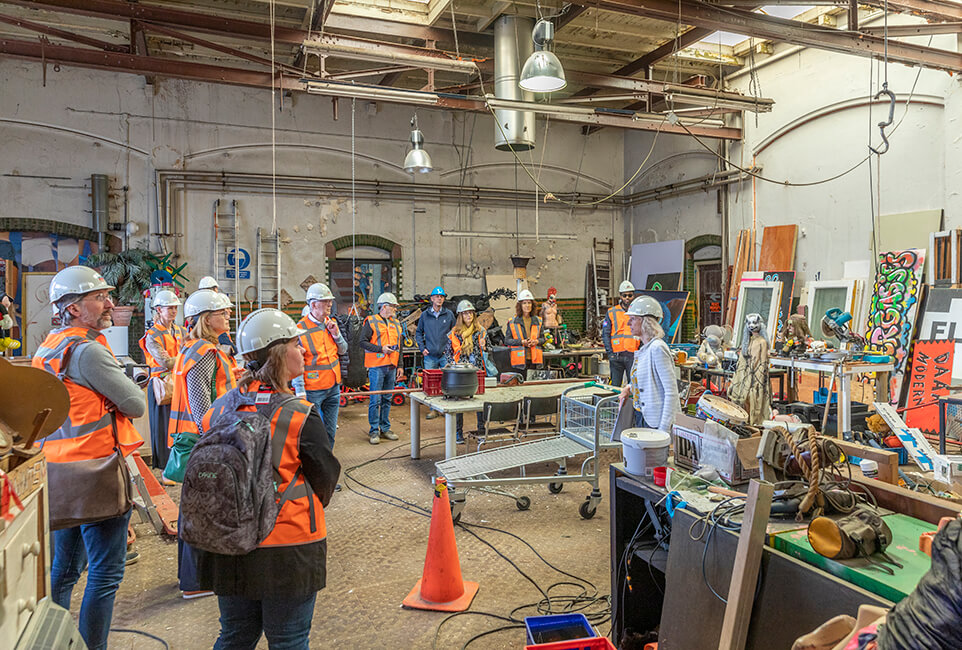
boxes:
[33,266,145,650]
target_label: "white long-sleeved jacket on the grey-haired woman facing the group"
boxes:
[631,339,681,433]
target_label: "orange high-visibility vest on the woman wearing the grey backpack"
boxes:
[203,381,327,548]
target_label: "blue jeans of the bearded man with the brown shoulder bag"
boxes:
[50,510,131,650]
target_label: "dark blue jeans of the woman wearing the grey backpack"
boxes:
[214,593,317,650]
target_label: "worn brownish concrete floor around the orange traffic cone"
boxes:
[94,403,613,650]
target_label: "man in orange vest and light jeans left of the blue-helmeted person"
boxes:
[360,292,404,445]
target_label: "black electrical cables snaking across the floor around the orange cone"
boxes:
[344,438,611,648]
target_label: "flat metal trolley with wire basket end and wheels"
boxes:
[435,382,621,521]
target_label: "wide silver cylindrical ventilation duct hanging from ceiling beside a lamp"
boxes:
[494,16,535,151]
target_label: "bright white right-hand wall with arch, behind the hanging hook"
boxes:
[625,12,962,292]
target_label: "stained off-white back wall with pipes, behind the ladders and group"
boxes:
[0,60,624,299]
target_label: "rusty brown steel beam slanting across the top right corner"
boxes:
[575,0,962,73]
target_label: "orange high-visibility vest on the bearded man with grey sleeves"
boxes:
[31,327,144,464]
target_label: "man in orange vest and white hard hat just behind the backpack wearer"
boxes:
[297,282,347,449]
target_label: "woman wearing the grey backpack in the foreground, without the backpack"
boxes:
[194,309,341,648]
